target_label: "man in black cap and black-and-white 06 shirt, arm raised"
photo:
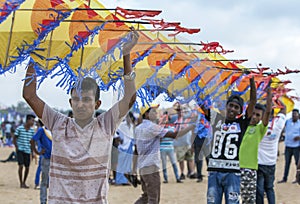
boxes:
[205,78,256,204]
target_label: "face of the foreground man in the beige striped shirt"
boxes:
[70,90,97,120]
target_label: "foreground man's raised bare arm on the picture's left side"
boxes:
[23,63,45,118]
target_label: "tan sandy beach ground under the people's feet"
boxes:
[0,143,300,204]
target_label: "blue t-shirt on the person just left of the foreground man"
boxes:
[32,128,52,159]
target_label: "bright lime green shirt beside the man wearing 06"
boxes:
[239,122,268,170]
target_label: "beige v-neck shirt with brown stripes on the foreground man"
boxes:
[42,104,121,204]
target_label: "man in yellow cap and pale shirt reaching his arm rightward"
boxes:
[135,105,195,204]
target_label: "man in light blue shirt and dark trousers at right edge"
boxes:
[278,109,300,183]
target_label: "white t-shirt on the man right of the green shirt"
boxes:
[258,113,286,165]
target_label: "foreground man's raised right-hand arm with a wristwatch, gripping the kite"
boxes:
[119,30,139,118]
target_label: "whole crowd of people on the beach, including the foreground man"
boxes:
[0,27,300,204]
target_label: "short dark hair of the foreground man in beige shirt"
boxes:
[71,77,100,101]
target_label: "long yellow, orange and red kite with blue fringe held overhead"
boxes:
[0,0,297,111]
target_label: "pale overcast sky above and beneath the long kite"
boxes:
[0,0,300,109]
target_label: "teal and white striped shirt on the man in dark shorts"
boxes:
[15,125,34,154]
